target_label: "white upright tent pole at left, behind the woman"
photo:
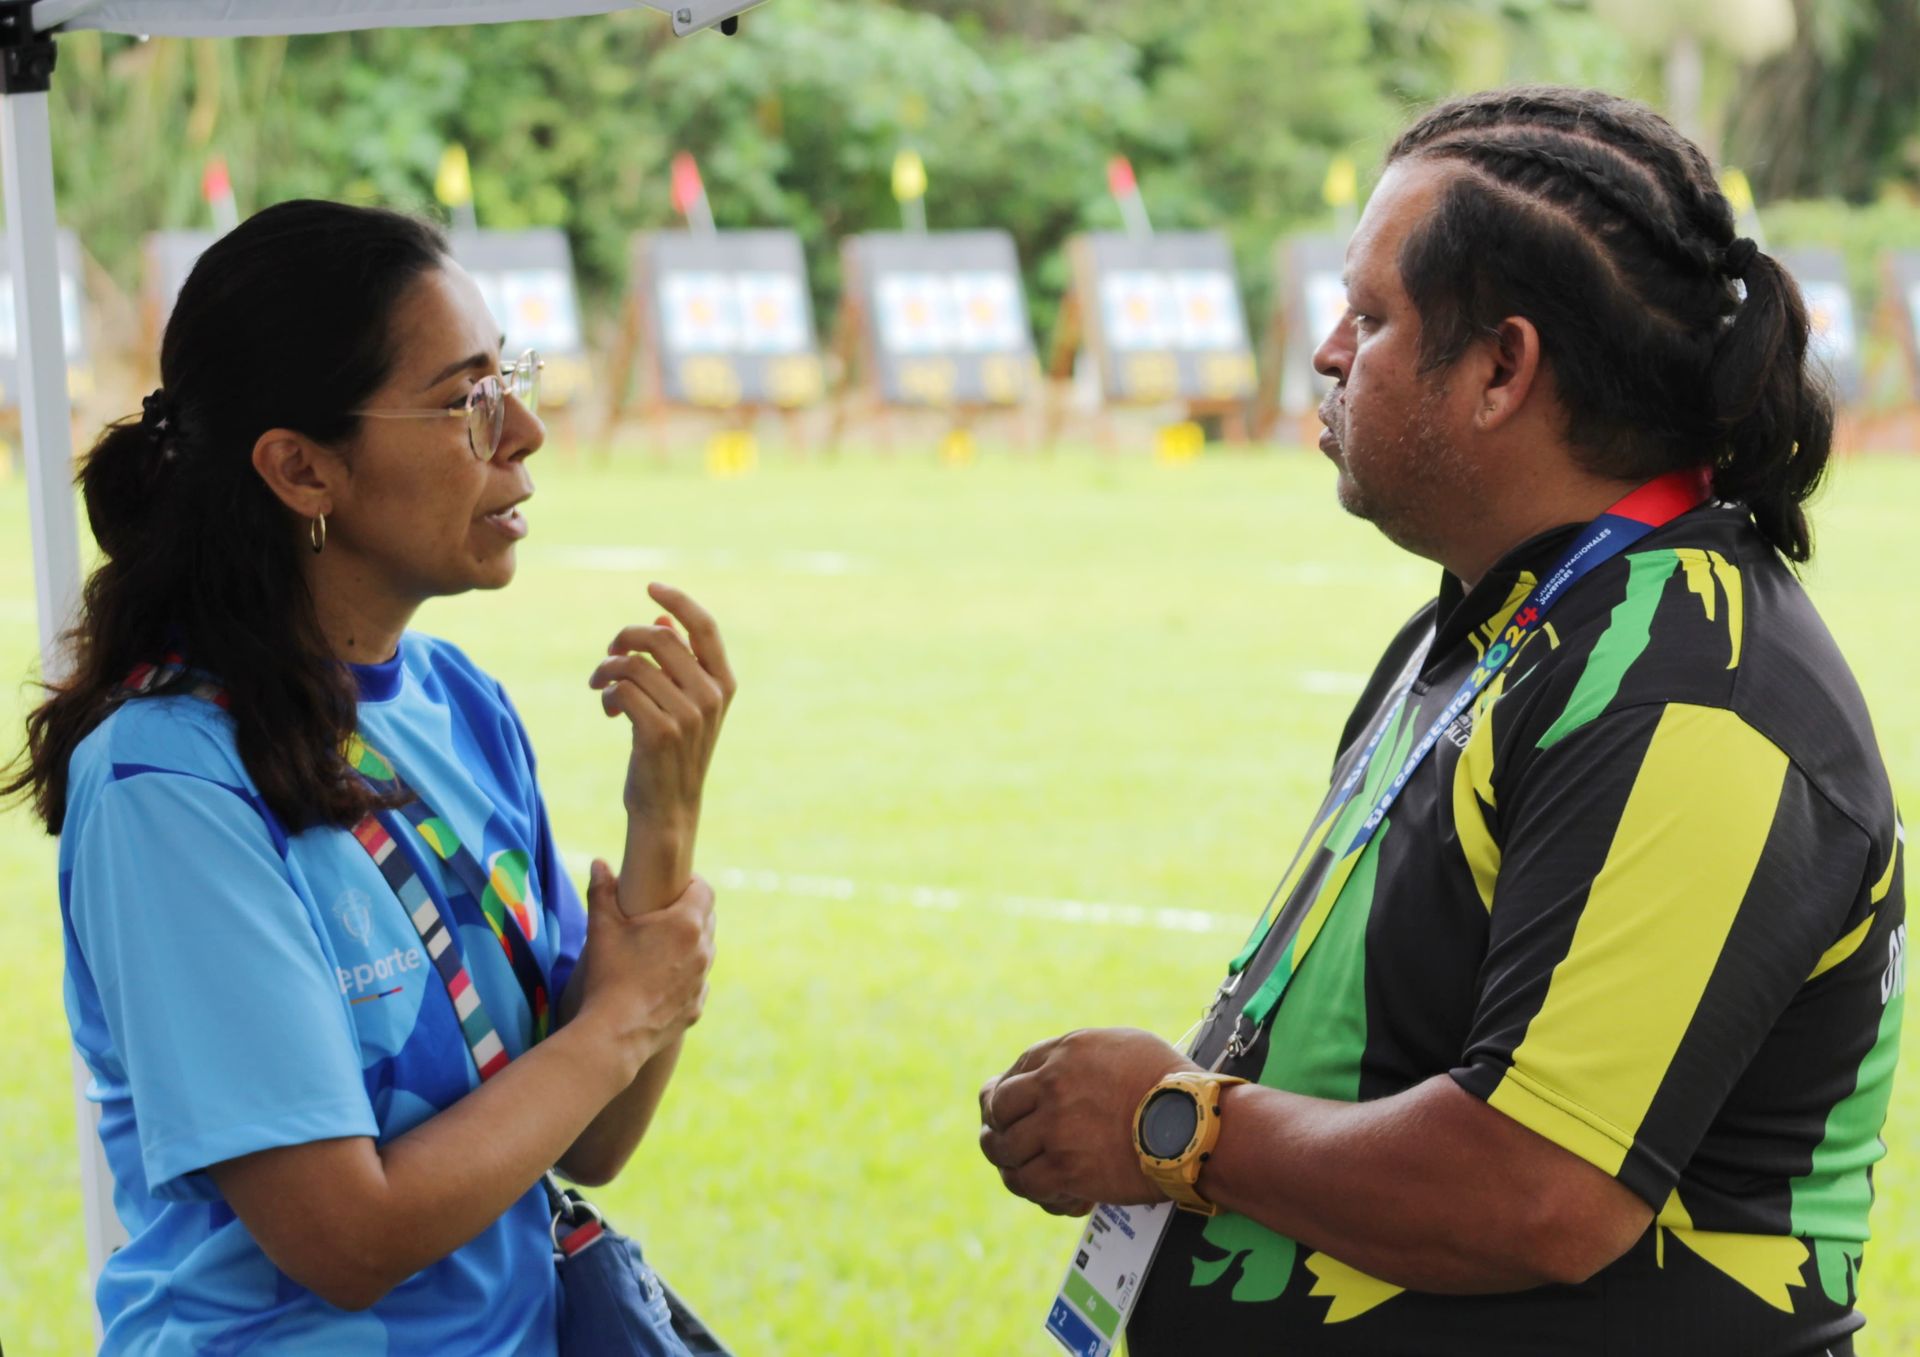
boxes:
[0,21,127,1334]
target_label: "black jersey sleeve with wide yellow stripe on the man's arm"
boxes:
[1452,704,1870,1209]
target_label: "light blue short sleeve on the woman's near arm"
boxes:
[67,772,378,1200]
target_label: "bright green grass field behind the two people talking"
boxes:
[0,455,1920,1357]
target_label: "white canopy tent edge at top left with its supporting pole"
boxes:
[0,0,762,1305]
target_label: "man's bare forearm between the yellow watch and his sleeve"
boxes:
[1200,1075,1651,1294]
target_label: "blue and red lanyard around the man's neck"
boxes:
[1221,470,1709,1056]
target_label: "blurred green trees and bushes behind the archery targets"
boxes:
[37,0,1920,338]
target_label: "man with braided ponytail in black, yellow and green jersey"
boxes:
[981,88,1907,1357]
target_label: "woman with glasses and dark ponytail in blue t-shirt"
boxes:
[12,202,733,1353]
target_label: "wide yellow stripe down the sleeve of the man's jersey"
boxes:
[1488,702,1788,1173]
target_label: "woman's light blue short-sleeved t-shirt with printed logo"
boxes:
[60,633,586,1357]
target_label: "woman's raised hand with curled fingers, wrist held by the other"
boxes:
[591,583,735,914]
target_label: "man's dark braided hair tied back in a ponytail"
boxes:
[1386,86,1834,560]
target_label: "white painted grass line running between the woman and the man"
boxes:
[561,852,1248,933]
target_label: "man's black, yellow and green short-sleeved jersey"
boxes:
[1129,507,1907,1357]
